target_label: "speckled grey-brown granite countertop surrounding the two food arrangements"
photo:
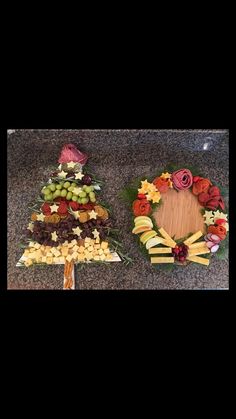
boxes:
[7,130,229,290]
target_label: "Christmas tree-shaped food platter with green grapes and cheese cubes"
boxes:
[16,144,131,289]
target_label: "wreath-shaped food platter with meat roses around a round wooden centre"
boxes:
[121,168,229,267]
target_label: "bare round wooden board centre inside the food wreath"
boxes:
[153,189,206,239]
